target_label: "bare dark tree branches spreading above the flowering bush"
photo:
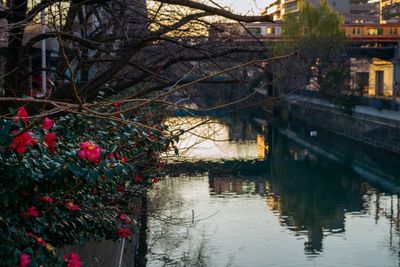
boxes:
[0,0,282,120]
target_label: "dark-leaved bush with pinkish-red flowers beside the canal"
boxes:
[0,108,172,266]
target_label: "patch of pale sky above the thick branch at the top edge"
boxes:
[216,0,272,15]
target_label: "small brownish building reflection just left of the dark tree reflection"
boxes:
[209,175,265,195]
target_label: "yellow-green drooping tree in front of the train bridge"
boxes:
[274,1,348,96]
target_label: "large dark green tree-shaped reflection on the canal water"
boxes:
[267,133,366,254]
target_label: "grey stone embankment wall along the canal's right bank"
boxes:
[288,96,400,154]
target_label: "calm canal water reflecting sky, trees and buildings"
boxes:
[145,118,400,267]
